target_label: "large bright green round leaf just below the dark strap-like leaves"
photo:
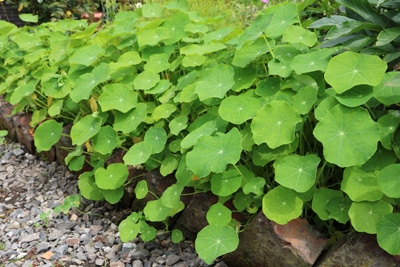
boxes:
[325,51,387,94]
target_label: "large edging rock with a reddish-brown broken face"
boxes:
[222,214,326,267]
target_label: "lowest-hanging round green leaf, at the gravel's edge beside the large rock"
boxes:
[195,225,239,264]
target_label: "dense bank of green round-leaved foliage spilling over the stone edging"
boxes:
[0,0,400,263]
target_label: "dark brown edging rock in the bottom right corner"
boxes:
[315,233,400,267]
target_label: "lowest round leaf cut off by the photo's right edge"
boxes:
[377,213,400,255]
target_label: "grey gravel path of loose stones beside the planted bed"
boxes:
[0,143,226,267]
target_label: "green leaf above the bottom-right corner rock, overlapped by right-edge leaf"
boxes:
[349,200,393,234]
